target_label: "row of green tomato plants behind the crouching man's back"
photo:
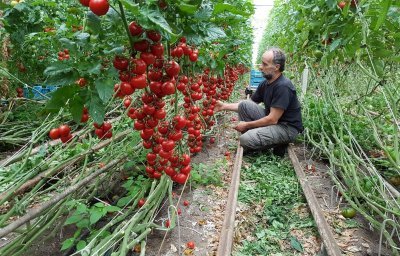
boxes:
[259,0,400,255]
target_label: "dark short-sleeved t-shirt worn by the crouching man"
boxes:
[251,75,303,132]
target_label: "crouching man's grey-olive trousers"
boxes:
[238,100,299,151]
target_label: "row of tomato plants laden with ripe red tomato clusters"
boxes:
[0,0,253,255]
